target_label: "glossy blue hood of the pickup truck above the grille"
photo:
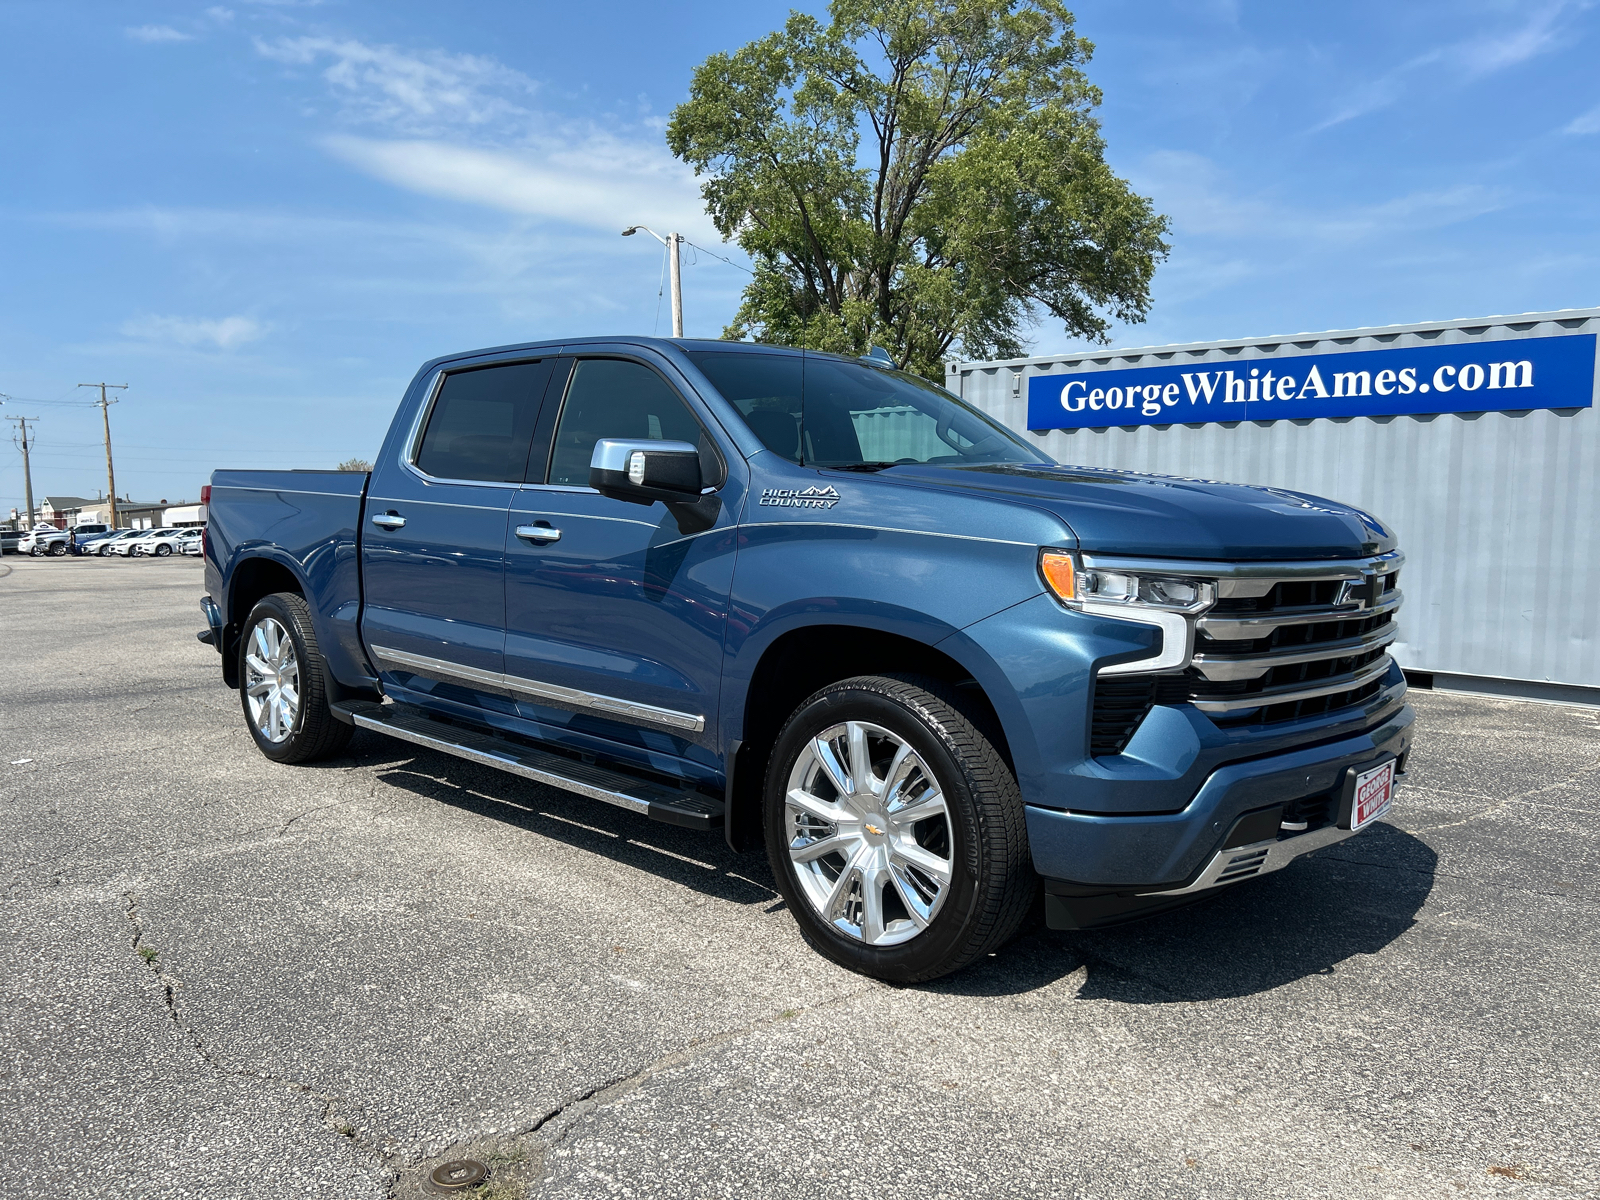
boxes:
[882,462,1395,562]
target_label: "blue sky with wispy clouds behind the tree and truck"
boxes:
[0,0,1600,512]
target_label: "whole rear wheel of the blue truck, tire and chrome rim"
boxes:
[238,592,352,763]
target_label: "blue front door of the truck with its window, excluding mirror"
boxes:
[506,357,738,773]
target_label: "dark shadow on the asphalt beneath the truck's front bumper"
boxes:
[926,824,1438,1005]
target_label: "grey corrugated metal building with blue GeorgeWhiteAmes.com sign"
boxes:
[946,309,1600,704]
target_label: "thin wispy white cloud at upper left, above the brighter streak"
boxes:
[256,37,538,136]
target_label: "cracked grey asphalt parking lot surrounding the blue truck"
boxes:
[0,557,1600,1200]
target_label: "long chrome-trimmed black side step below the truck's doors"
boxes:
[330,701,723,830]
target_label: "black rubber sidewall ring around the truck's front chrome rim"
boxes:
[762,686,982,981]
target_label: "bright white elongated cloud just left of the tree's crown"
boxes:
[323,134,717,242]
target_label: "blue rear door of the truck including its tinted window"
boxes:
[362,358,552,704]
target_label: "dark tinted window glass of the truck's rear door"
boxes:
[416,362,550,483]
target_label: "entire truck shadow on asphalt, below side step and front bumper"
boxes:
[328,734,1438,1005]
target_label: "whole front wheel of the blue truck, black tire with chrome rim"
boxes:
[762,675,1037,984]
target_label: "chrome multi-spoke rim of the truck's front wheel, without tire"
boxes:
[784,722,955,946]
